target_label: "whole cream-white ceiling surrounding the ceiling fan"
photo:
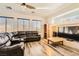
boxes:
[0,3,79,18]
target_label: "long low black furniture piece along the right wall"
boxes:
[53,32,79,41]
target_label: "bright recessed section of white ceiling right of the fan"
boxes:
[26,3,62,9]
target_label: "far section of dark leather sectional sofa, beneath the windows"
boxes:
[13,31,41,42]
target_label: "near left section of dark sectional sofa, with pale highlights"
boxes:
[0,33,24,56]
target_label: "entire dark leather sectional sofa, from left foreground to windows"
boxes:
[0,31,41,56]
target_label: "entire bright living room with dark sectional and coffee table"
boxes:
[0,3,79,56]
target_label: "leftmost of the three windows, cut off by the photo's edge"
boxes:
[0,16,13,32]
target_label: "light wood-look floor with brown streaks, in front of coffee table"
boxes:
[24,41,79,56]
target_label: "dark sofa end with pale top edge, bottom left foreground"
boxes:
[0,44,24,56]
